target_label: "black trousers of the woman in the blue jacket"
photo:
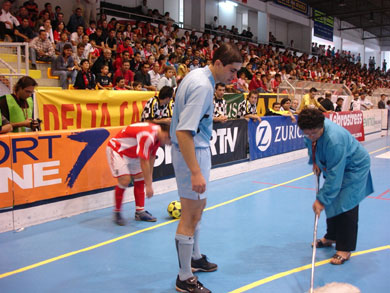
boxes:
[324,205,359,251]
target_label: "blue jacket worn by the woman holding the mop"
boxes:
[305,119,374,218]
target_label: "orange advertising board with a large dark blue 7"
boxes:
[0,127,122,208]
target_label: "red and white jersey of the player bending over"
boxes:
[108,123,160,160]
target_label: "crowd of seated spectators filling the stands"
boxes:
[0,0,390,100]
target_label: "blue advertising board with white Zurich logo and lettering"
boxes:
[248,116,305,160]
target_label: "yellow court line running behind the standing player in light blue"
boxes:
[0,147,389,279]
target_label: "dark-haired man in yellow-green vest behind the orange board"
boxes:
[0,76,39,132]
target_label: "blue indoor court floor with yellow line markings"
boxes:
[0,136,390,293]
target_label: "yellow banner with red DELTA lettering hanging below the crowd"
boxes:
[35,90,156,130]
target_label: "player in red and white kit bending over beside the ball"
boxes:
[107,123,170,226]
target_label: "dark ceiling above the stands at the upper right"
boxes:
[307,0,390,45]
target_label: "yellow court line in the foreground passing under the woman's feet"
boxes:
[229,245,390,293]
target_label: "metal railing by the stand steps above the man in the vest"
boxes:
[0,42,29,91]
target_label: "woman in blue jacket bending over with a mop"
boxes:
[298,109,374,265]
